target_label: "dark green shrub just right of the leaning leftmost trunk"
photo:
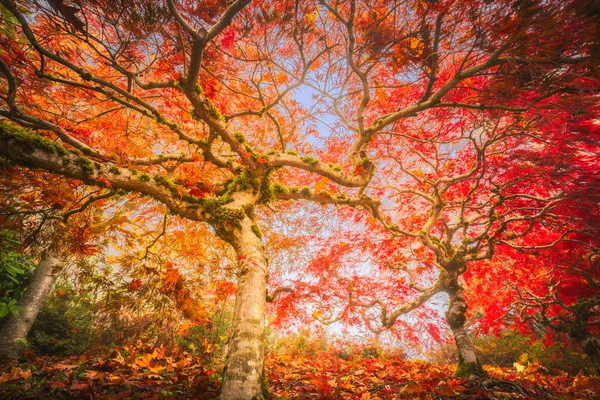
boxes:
[27,284,95,355]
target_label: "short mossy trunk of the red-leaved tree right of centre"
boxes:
[446,286,487,378]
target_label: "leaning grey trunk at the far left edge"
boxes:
[0,250,64,358]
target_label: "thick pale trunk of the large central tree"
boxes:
[220,217,268,400]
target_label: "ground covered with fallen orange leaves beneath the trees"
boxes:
[0,347,600,400]
